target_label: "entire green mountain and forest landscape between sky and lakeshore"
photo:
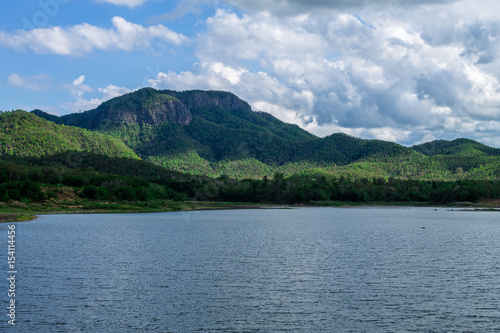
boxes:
[0,88,500,207]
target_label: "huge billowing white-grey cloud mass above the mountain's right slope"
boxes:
[150,0,500,146]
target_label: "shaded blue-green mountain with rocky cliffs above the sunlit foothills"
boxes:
[33,88,412,167]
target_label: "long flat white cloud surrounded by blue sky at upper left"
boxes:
[0,16,187,56]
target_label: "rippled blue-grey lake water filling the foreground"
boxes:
[0,208,500,332]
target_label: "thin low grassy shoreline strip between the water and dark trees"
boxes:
[0,200,500,223]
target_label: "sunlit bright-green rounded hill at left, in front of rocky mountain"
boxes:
[0,110,138,159]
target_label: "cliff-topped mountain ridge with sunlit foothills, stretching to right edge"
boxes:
[32,88,500,179]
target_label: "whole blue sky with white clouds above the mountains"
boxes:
[0,0,500,147]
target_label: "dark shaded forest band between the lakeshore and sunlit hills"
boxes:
[0,152,500,204]
